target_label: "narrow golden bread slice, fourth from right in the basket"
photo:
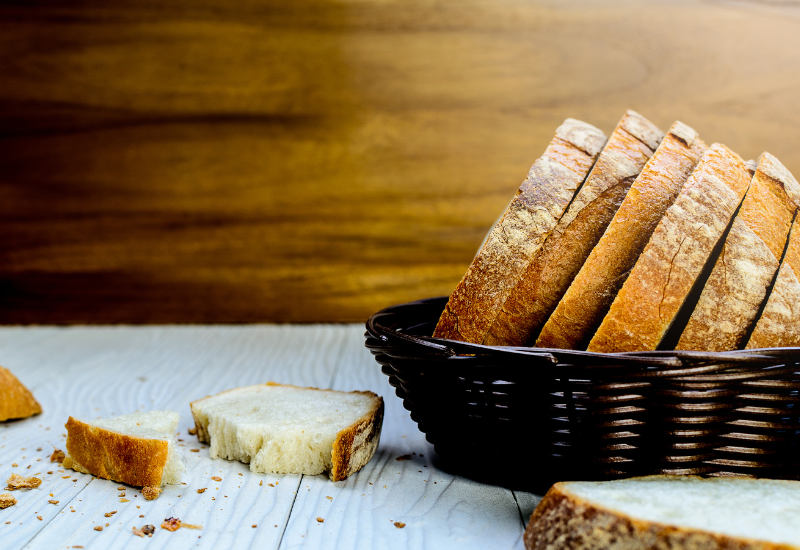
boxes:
[536,122,706,349]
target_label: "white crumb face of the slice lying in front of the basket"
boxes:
[564,476,800,545]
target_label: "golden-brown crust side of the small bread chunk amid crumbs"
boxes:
[65,416,169,487]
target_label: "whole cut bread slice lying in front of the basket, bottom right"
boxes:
[524,476,800,550]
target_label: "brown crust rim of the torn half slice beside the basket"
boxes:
[189,382,384,481]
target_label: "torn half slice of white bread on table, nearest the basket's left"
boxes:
[191,382,383,481]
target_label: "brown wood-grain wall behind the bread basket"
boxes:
[0,0,800,323]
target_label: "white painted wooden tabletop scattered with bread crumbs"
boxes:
[0,325,539,550]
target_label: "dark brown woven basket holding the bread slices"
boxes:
[365,296,800,492]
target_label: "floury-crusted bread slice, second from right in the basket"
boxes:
[676,153,800,351]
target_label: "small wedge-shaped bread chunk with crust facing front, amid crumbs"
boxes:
[63,411,186,487]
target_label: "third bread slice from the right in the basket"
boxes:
[588,143,751,353]
